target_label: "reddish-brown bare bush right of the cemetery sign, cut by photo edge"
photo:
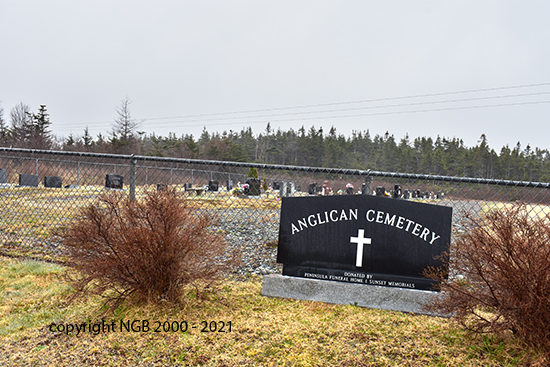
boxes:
[431,204,550,351]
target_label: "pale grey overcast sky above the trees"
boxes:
[0,0,550,152]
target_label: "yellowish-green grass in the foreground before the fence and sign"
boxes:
[0,257,542,366]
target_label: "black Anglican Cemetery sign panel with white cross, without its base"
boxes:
[277,195,452,290]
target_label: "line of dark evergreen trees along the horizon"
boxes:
[0,99,550,182]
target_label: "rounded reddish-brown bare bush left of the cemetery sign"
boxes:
[59,190,239,306]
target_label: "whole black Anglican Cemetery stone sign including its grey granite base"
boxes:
[262,195,452,313]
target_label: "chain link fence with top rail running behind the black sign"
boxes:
[0,148,550,264]
